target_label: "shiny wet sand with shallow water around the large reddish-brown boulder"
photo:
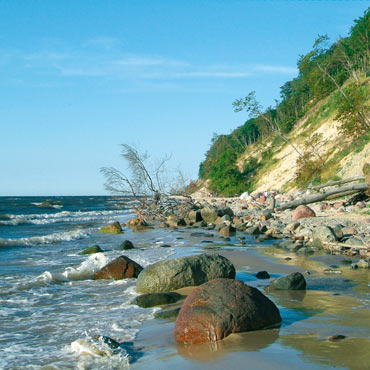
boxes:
[131,238,370,370]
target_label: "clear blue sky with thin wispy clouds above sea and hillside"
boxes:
[0,0,369,195]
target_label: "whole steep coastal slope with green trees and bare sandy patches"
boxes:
[199,8,370,196]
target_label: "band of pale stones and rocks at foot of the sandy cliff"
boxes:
[180,193,370,267]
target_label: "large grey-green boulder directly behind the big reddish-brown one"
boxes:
[136,254,235,293]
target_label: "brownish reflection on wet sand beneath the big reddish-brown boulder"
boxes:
[176,329,279,362]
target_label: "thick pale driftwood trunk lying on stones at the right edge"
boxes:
[276,182,370,211]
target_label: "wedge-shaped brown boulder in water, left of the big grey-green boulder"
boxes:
[93,256,143,280]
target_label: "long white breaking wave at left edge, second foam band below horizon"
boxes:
[0,229,92,247]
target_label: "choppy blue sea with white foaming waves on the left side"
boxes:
[0,196,181,369]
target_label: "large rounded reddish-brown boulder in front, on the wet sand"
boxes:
[174,279,281,344]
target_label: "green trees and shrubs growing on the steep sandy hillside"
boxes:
[199,8,370,194]
